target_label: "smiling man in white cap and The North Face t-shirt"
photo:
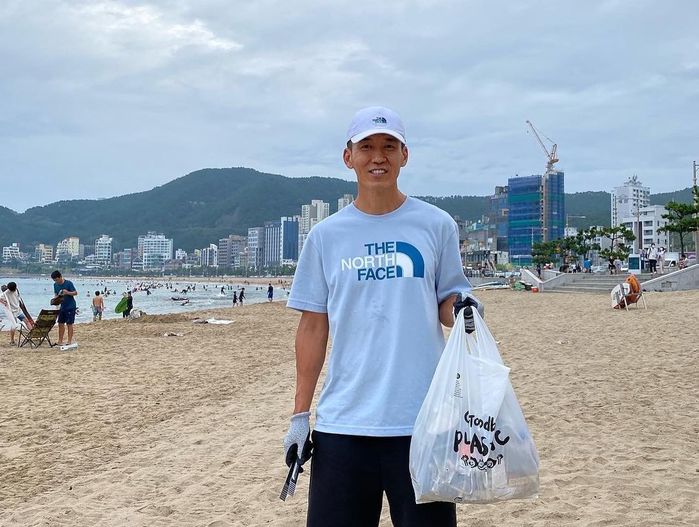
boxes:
[284,107,471,527]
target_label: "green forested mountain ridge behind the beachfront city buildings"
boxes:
[0,167,691,251]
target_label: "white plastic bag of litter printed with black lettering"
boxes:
[410,309,539,503]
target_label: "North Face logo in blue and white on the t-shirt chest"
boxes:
[340,242,425,281]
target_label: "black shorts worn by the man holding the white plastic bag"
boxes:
[307,431,456,527]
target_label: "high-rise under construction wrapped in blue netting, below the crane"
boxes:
[507,170,565,265]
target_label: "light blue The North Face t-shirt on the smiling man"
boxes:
[287,197,471,436]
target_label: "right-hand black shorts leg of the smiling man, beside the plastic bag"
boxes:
[379,436,456,527]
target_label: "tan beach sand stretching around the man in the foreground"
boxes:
[0,291,699,527]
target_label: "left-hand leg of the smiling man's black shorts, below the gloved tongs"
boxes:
[306,432,383,527]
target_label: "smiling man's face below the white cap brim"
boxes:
[342,134,408,191]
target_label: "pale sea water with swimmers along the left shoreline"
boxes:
[0,274,288,322]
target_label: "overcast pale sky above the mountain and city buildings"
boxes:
[0,0,699,211]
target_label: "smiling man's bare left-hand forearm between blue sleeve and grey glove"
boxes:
[294,311,329,414]
